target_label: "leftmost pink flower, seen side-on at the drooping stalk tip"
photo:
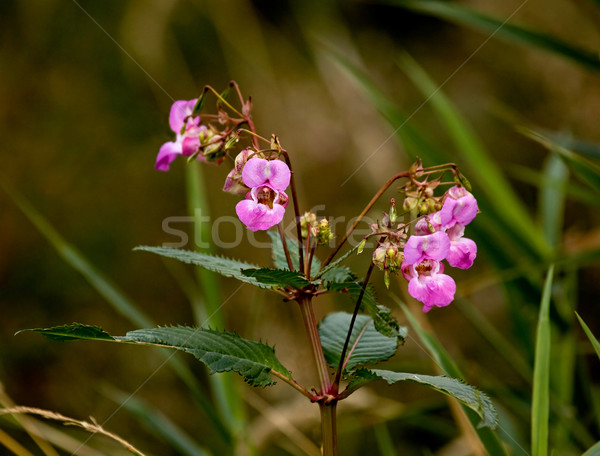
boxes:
[154,99,206,171]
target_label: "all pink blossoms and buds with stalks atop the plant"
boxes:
[155,91,478,312]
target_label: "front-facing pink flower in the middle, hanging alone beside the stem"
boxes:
[235,158,291,231]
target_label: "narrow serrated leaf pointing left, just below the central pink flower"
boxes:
[134,246,273,288]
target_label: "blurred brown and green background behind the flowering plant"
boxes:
[0,0,600,455]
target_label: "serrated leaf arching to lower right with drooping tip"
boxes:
[348,369,497,429]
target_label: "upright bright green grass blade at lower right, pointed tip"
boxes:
[531,266,554,456]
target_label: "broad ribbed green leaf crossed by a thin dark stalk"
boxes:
[319,312,404,370]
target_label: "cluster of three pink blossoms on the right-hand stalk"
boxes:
[401,186,478,312]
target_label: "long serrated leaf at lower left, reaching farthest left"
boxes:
[24,324,292,386]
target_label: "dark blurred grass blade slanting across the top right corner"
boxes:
[389,0,600,71]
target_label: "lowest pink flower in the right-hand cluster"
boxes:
[402,259,456,312]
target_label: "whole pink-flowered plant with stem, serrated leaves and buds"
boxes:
[21,82,496,455]
